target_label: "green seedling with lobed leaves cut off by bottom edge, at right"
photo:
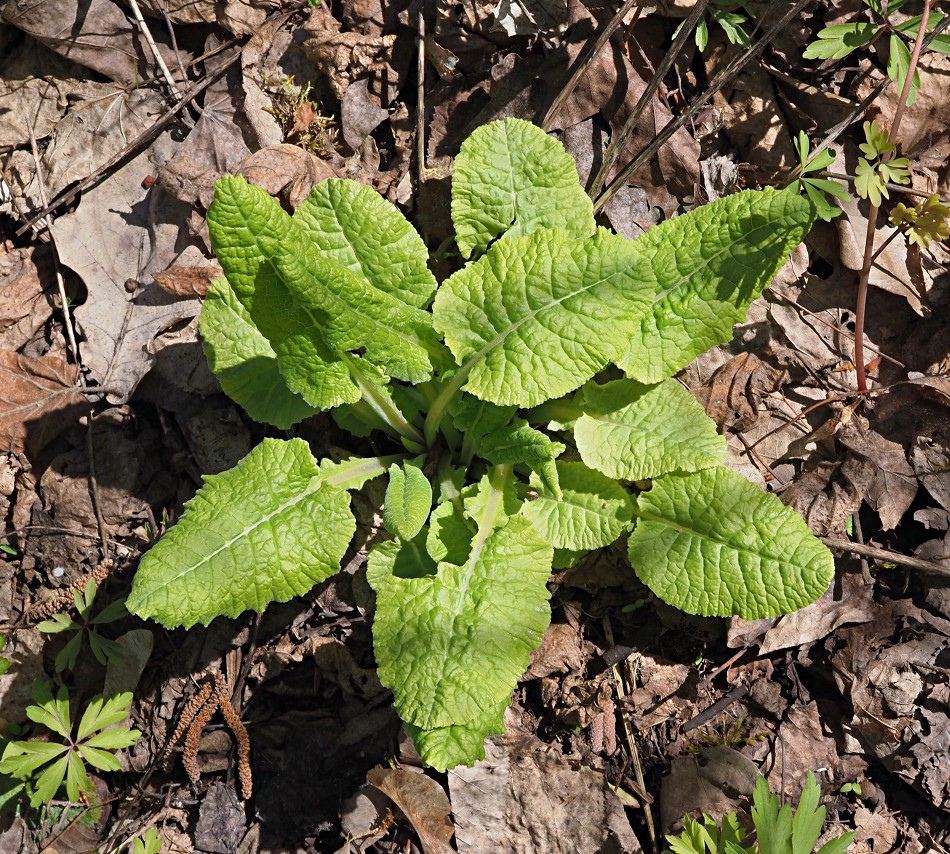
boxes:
[666,771,854,854]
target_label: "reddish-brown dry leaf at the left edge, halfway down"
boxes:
[0,350,86,455]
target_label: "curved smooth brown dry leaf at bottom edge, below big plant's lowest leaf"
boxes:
[366,768,455,854]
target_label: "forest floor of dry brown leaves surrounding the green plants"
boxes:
[0,0,950,854]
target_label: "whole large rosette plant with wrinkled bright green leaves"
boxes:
[127,119,833,769]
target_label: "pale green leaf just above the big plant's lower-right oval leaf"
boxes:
[574,380,726,480]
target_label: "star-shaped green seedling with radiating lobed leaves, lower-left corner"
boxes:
[0,679,142,807]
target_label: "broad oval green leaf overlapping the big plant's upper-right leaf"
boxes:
[433,229,653,406]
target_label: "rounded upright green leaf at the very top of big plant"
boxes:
[452,119,594,258]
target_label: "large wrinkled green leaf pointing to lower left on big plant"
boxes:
[126,439,356,627]
